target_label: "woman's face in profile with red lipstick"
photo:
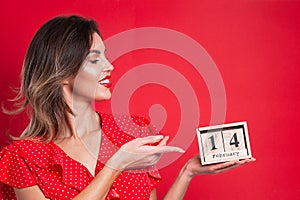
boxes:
[72,33,114,101]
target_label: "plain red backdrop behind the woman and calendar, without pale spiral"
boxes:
[0,0,300,199]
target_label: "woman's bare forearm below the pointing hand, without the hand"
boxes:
[74,166,120,200]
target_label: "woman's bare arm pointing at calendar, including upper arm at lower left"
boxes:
[14,135,183,200]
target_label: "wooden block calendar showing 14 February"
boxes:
[197,122,251,165]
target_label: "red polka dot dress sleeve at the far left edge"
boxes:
[0,144,36,188]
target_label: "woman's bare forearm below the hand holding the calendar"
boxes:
[164,167,192,200]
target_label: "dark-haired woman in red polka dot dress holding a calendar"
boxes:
[0,16,254,200]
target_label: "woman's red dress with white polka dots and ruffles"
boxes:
[0,114,161,200]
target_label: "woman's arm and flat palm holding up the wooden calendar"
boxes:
[164,156,255,200]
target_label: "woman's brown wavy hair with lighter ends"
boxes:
[2,15,100,141]
